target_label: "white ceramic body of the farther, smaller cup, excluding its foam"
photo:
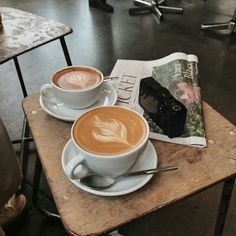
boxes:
[40,66,104,109]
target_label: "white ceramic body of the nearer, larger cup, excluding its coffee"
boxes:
[65,106,149,179]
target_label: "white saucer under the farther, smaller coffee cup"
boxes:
[39,82,117,122]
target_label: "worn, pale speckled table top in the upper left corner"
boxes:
[0,7,72,64]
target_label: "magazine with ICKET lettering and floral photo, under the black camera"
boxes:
[110,52,207,147]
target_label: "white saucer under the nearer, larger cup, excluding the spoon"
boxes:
[61,140,158,196]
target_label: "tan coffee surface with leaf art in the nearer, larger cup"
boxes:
[73,106,147,156]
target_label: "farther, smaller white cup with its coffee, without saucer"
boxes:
[40,66,104,109]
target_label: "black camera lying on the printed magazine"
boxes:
[139,77,187,138]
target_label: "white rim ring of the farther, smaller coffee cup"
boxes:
[51,65,104,93]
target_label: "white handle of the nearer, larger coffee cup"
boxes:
[65,155,89,179]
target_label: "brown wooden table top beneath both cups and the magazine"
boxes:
[23,94,236,235]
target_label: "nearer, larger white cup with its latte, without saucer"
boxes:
[65,106,149,179]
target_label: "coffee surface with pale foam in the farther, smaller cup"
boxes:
[53,67,101,90]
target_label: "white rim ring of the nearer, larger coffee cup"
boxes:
[71,105,150,159]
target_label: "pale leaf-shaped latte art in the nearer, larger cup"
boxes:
[92,116,132,146]
